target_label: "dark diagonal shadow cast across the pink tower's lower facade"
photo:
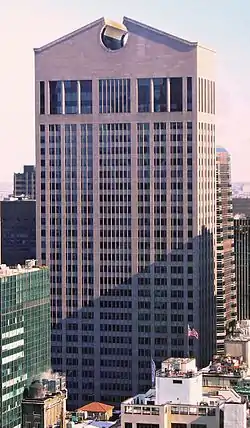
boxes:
[52,227,216,410]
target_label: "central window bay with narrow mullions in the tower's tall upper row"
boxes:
[99,79,130,113]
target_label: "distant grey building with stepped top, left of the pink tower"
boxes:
[13,165,36,199]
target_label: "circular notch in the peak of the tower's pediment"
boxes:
[101,20,128,51]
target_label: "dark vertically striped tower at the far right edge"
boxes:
[234,215,250,320]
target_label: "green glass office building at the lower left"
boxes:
[0,261,51,428]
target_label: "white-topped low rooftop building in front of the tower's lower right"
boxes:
[121,358,247,428]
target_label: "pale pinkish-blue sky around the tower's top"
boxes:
[0,0,250,183]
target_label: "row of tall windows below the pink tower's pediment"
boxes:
[39,77,215,114]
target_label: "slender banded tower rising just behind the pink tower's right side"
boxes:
[216,147,237,354]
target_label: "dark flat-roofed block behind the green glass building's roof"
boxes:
[0,198,36,266]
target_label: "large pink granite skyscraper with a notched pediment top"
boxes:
[35,18,216,407]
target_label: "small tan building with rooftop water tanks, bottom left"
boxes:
[22,375,67,428]
